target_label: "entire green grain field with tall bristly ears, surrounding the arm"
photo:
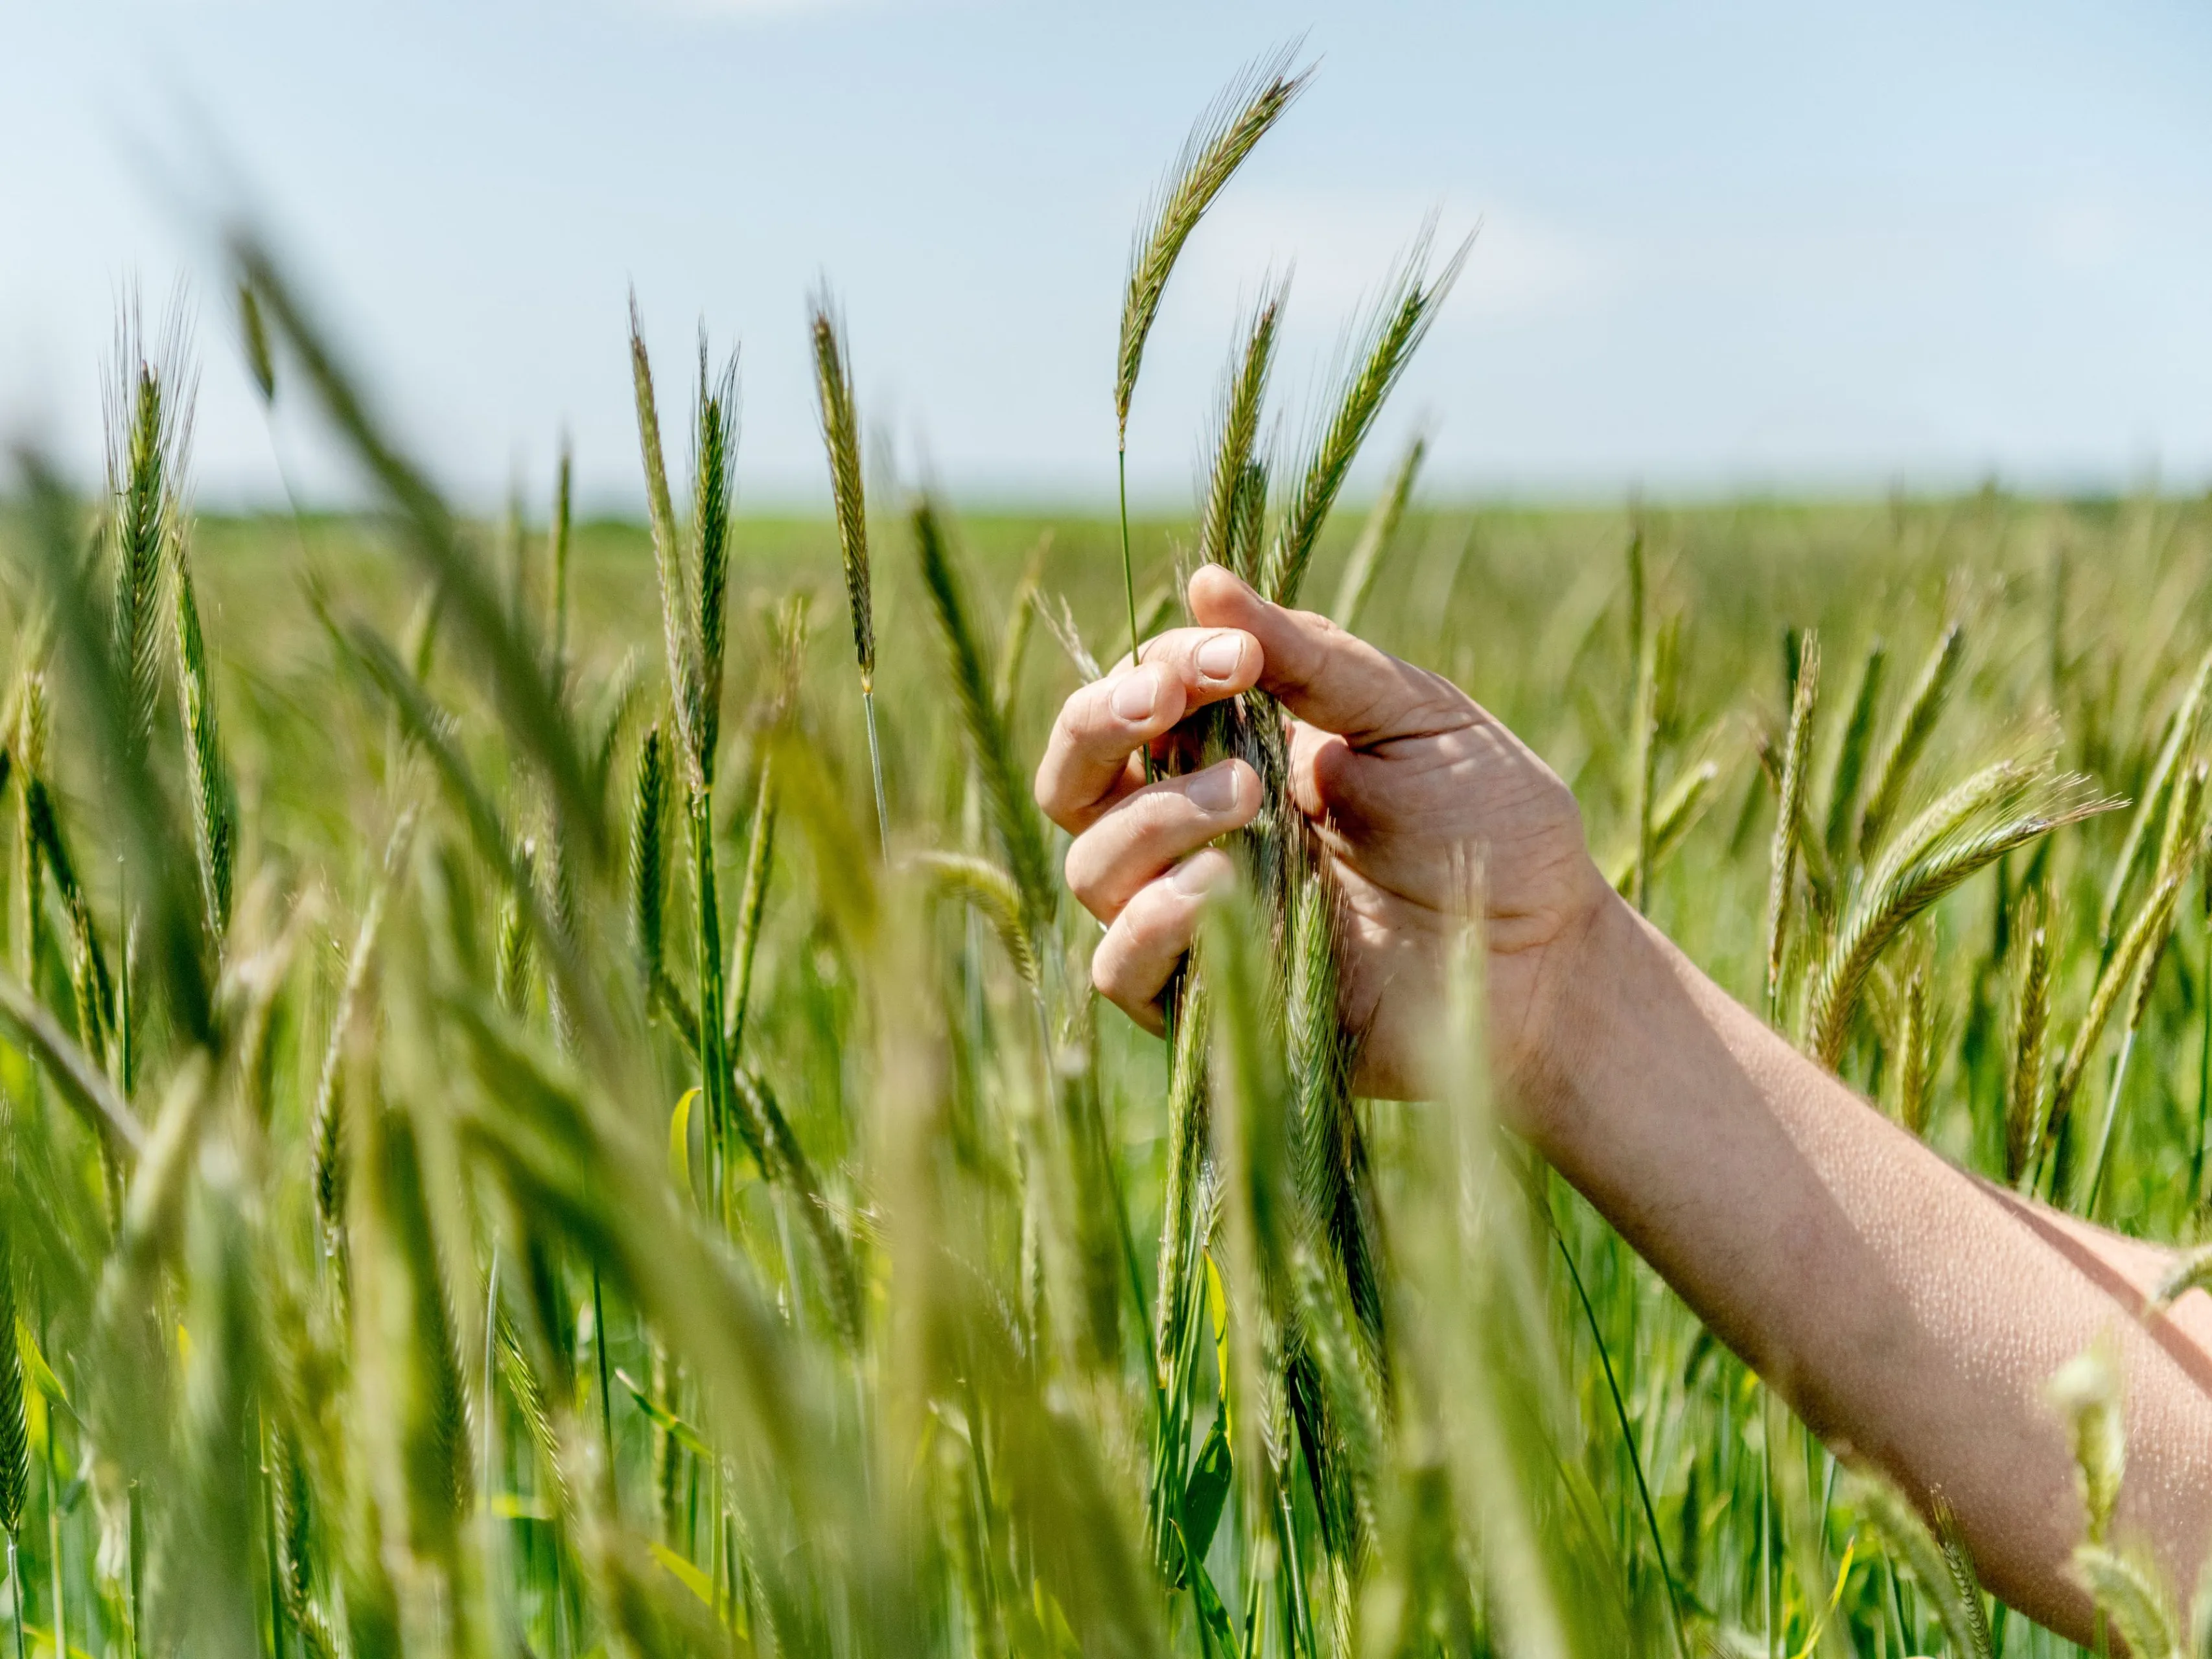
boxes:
[0,52,2212,1659]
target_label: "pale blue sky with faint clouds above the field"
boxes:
[0,0,2212,509]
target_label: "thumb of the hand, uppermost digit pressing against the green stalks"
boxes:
[1190,564,1473,748]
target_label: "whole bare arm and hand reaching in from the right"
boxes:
[1038,566,2212,1642]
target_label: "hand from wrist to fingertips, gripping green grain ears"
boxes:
[1035,566,1612,1097]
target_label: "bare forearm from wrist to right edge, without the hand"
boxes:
[1522,889,2212,1634]
